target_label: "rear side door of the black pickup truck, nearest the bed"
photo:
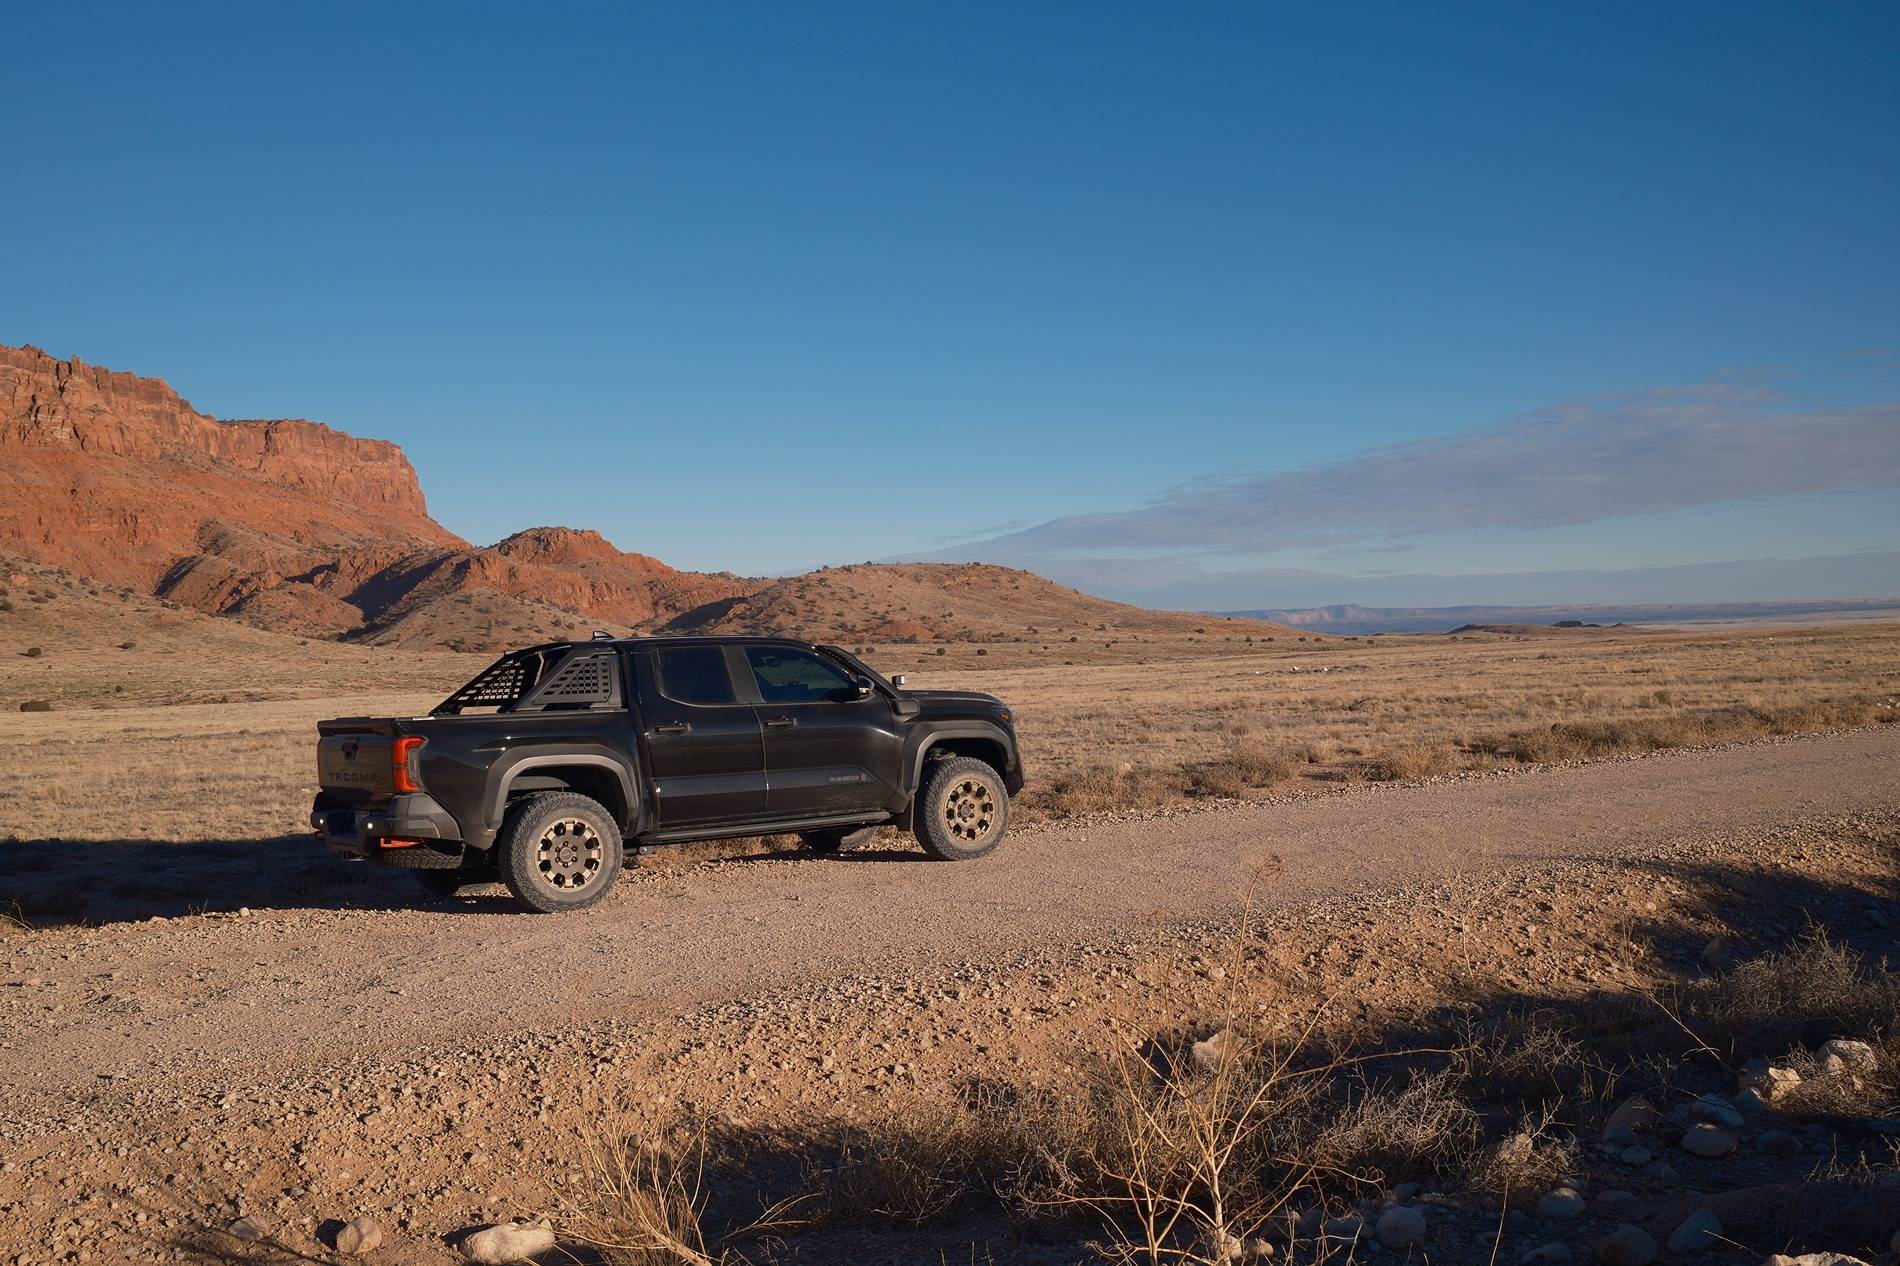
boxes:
[635,644,766,829]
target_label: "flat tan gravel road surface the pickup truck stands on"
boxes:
[0,726,1900,1120]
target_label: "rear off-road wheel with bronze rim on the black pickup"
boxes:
[494,791,625,914]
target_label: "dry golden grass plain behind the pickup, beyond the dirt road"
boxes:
[0,582,1900,840]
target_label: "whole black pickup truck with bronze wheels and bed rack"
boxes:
[310,637,1022,911]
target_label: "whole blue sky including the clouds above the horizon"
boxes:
[0,4,1900,606]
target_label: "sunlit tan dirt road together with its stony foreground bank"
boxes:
[0,726,1900,1262]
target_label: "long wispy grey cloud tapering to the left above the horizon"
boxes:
[919,382,1900,566]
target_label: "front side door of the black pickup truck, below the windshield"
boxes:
[743,643,903,817]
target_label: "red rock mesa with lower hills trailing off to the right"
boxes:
[0,346,1271,650]
